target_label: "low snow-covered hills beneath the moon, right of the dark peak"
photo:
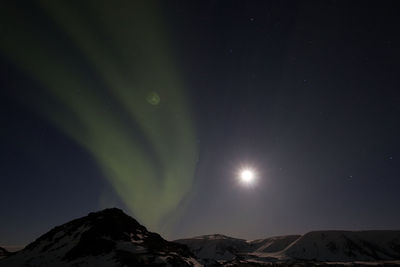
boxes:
[175,231,400,266]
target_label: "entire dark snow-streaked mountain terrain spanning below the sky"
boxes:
[0,208,400,267]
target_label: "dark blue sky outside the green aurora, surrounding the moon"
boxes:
[0,0,400,245]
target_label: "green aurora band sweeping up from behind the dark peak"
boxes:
[0,1,197,229]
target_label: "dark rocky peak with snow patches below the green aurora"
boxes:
[0,208,200,267]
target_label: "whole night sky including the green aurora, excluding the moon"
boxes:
[0,0,400,248]
